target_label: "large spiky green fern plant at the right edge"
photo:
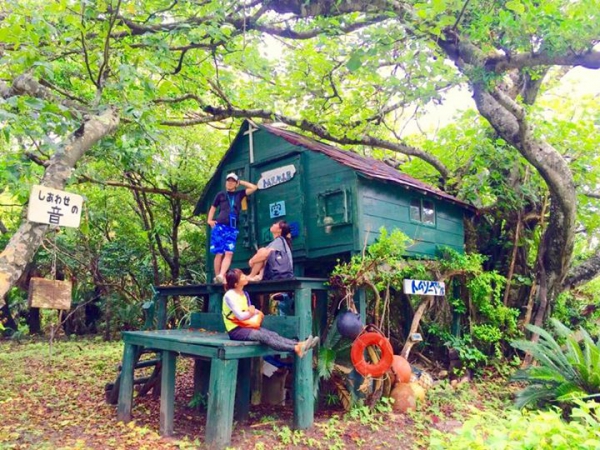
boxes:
[512,319,600,408]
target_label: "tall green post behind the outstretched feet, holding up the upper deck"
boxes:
[294,288,315,430]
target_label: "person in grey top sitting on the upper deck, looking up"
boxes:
[248,220,294,281]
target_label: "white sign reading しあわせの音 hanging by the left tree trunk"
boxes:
[27,185,83,228]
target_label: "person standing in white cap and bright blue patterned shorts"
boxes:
[207,172,258,283]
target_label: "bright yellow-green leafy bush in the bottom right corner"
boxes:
[429,402,600,450]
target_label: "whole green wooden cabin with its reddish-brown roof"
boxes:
[194,121,475,276]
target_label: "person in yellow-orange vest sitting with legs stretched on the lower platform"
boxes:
[223,269,319,358]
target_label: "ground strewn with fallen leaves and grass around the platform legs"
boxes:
[0,338,510,450]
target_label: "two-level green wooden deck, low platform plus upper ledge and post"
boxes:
[117,279,327,448]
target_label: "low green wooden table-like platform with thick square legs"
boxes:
[117,330,304,448]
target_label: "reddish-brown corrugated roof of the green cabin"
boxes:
[258,124,477,211]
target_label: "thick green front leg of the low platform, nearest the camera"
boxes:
[206,359,238,448]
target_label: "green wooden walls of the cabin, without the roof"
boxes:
[203,125,464,275]
